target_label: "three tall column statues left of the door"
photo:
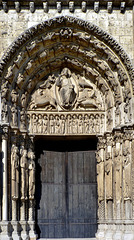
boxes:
[11,145,35,200]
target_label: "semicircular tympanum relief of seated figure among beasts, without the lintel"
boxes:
[28,68,104,111]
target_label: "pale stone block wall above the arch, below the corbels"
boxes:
[0,6,134,63]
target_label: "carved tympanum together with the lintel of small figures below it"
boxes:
[27,68,105,135]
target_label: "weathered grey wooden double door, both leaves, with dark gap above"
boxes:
[36,138,97,238]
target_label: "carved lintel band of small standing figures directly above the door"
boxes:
[29,113,105,134]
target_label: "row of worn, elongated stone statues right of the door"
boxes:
[97,147,131,201]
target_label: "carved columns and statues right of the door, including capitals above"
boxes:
[96,133,134,219]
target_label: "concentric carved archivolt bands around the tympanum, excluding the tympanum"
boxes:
[0,16,133,130]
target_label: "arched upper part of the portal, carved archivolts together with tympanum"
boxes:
[0,17,134,134]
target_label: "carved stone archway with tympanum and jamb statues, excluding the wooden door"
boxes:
[0,16,134,239]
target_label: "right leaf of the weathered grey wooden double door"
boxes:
[68,152,97,238]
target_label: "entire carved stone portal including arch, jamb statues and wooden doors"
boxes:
[0,16,134,240]
